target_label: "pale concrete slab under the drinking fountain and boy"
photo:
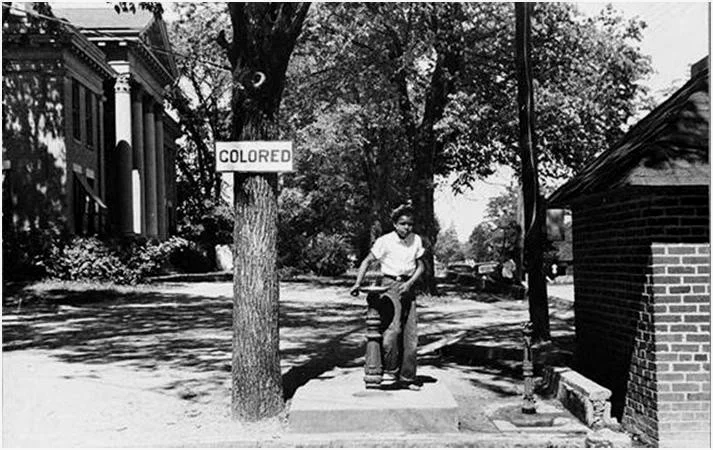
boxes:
[289,368,458,433]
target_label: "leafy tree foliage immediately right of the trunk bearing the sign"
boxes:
[285,3,411,257]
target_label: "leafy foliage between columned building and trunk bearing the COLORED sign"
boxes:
[166,3,233,255]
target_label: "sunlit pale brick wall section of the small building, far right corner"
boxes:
[648,243,710,447]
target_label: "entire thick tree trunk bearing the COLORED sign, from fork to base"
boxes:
[218,3,309,420]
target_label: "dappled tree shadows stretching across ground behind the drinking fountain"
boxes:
[3,285,572,399]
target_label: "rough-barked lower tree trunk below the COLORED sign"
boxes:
[232,173,284,421]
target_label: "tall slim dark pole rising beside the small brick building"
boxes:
[515,2,550,340]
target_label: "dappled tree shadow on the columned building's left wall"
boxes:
[2,38,77,279]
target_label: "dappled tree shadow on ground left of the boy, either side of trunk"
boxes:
[3,286,366,398]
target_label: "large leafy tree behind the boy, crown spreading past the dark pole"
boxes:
[284,3,650,294]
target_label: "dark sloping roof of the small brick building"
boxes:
[548,58,710,207]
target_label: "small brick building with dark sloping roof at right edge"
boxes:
[549,58,710,447]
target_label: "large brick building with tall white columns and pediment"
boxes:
[2,4,178,238]
